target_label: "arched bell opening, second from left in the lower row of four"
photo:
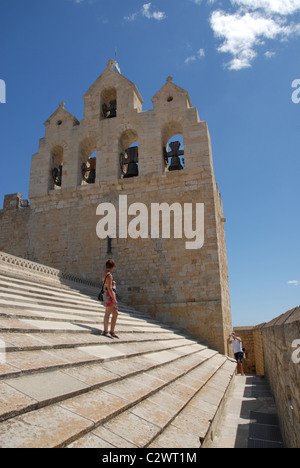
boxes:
[79,138,97,185]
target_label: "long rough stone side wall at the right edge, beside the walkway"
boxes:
[262,307,300,448]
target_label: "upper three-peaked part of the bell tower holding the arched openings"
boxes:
[29,60,212,197]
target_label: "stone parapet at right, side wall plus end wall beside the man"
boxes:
[235,307,300,448]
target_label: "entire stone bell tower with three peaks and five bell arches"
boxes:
[0,60,231,353]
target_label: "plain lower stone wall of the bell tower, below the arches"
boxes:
[0,166,231,352]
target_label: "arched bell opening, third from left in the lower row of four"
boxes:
[119,130,139,179]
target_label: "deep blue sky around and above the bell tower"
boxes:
[0,0,300,326]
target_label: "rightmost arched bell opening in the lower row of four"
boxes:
[162,121,185,172]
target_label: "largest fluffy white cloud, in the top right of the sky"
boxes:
[210,8,300,70]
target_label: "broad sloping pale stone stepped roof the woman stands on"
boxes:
[0,253,236,448]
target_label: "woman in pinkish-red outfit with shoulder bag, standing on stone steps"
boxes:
[102,260,119,338]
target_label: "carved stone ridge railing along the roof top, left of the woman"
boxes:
[0,252,99,288]
